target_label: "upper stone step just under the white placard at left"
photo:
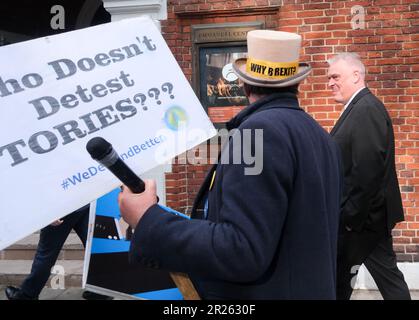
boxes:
[0,232,84,261]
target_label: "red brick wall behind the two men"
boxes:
[162,0,419,261]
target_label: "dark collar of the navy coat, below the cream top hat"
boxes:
[227,92,302,130]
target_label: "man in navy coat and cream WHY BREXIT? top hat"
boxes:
[119,30,341,299]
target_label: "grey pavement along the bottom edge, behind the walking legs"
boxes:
[0,285,419,300]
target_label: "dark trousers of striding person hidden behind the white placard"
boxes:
[21,205,89,297]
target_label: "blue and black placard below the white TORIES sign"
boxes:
[86,188,189,300]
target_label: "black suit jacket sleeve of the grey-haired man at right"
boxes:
[343,100,388,231]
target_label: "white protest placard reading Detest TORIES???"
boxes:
[0,17,215,249]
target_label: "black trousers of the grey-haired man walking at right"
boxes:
[337,225,411,300]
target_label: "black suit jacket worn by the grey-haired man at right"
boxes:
[331,88,404,232]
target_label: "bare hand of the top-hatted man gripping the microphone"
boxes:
[118,180,157,229]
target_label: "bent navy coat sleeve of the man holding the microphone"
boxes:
[131,116,294,282]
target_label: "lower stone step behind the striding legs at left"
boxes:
[0,260,83,289]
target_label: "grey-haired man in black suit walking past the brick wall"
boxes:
[328,53,410,299]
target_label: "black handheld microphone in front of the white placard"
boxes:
[86,137,145,193]
